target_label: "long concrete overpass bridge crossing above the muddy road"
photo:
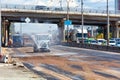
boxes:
[1,5,120,46]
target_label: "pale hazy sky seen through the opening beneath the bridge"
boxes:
[14,23,58,34]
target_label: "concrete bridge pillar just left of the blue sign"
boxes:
[58,19,65,41]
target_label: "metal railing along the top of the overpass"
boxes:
[1,4,120,14]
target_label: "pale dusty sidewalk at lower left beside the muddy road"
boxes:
[0,48,45,80]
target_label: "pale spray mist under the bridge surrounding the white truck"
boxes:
[12,23,62,46]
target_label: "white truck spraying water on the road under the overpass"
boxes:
[32,34,51,52]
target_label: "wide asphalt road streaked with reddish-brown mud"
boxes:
[11,45,120,80]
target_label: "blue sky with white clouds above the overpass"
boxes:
[1,0,115,10]
